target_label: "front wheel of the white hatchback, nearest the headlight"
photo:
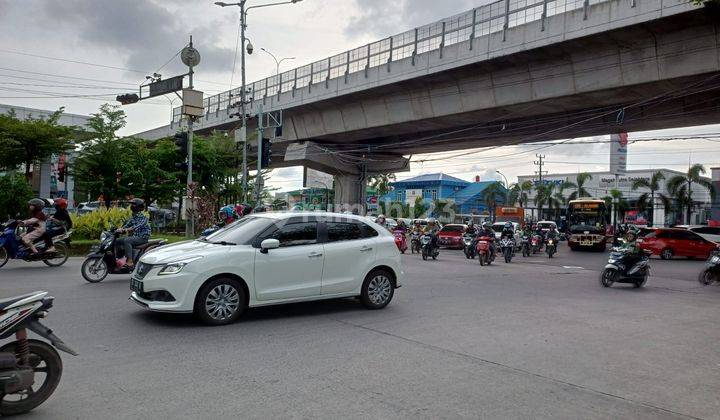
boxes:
[195,278,246,325]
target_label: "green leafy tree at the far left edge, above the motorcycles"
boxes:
[0,108,75,179]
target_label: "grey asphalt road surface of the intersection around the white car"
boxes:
[0,247,720,419]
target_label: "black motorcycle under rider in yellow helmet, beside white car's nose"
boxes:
[80,228,167,283]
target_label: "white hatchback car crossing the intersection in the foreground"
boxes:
[130,212,405,325]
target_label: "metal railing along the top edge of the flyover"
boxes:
[173,0,609,124]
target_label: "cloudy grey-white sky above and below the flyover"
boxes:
[0,0,720,190]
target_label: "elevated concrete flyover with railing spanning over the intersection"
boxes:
[136,0,720,205]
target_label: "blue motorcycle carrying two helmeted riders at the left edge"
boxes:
[0,220,72,267]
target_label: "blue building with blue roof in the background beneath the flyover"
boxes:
[381,173,502,214]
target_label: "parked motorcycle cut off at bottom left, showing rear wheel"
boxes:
[0,292,77,416]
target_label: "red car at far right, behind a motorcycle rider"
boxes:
[638,229,718,260]
